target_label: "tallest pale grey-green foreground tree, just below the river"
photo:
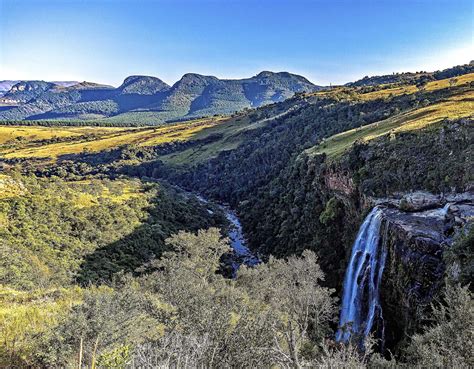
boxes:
[142,228,271,367]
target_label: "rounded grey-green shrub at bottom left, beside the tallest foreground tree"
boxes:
[35,281,166,367]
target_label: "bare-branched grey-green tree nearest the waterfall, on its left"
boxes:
[237,250,336,368]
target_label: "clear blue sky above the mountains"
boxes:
[0,0,474,85]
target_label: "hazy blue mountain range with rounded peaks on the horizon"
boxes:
[0,71,321,124]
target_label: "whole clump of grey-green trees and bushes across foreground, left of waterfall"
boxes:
[1,228,335,367]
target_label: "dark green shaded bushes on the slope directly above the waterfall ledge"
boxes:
[339,119,474,196]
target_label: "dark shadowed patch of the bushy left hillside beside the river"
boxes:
[76,187,225,284]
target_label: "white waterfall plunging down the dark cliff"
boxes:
[336,207,387,342]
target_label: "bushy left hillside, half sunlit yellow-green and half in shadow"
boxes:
[0,175,217,288]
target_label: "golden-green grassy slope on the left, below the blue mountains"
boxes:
[0,102,281,165]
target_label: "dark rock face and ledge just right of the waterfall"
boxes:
[374,193,474,348]
